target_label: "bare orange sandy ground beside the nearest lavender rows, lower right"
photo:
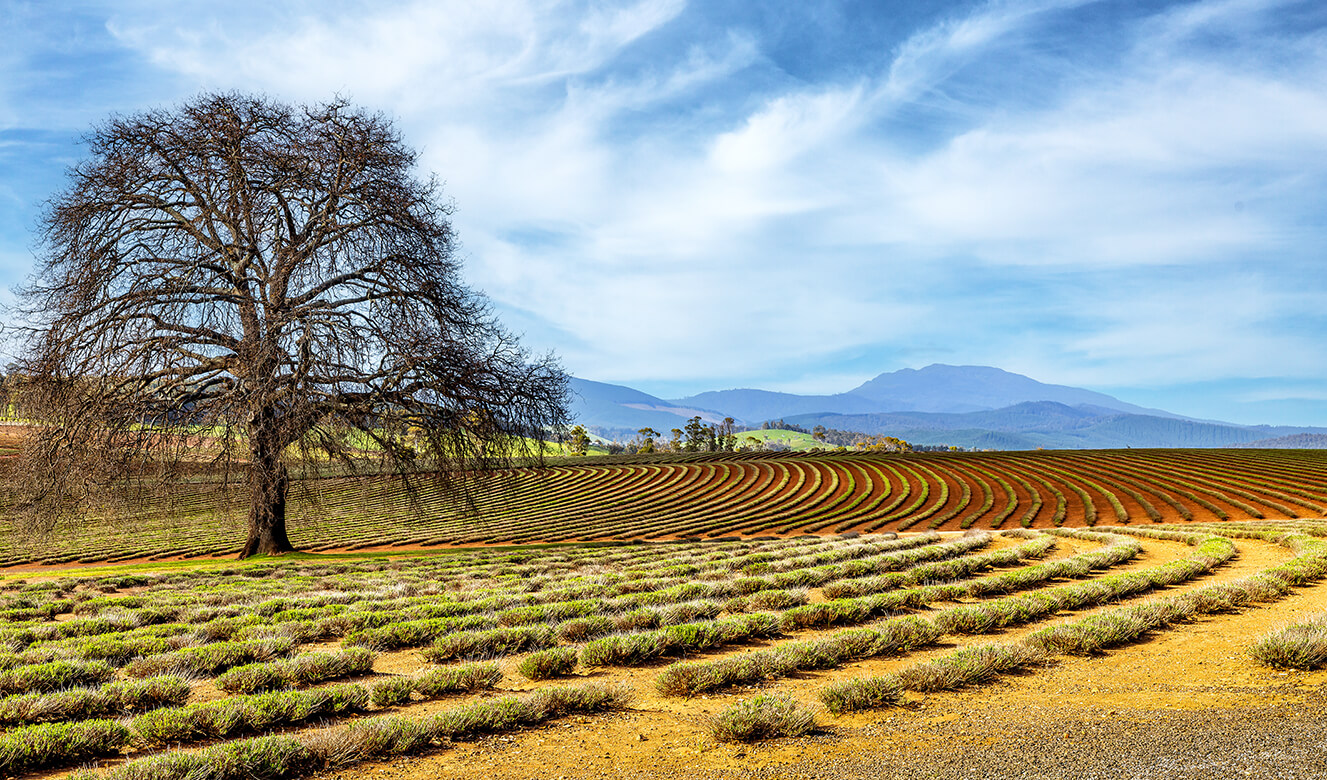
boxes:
[266,540,1327,780]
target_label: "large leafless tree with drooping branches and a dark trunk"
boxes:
[17,94,567,557]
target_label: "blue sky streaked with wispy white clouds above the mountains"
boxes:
[0,0,1327,424]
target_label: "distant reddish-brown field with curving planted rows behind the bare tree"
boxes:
[0,450,1327,565]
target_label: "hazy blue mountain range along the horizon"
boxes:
[572,365,1327,450]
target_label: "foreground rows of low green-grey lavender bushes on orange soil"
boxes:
[0,520,1327,780]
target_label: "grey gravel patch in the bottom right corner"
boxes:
[733,690,1327,780]
